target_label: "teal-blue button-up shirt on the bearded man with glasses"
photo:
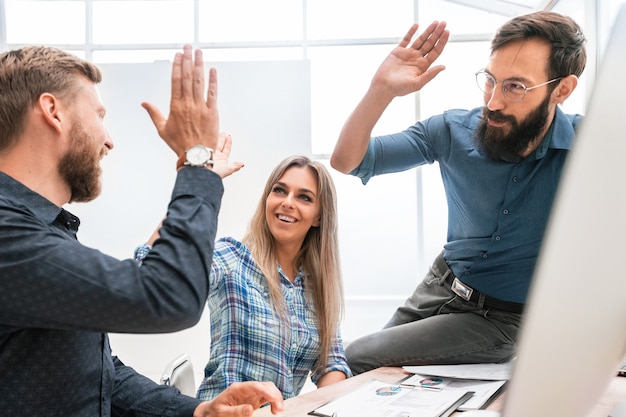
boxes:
[351,108,582,303]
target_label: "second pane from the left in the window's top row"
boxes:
[93,0,194,44]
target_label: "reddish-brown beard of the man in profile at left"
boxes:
[59,123,106,203]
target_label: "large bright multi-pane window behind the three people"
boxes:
[0,0,625,384]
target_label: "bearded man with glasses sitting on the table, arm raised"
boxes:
[330,11,586,374]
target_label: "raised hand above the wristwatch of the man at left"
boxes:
[141,45,219,156]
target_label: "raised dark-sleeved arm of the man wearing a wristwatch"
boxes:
[0,168,223,333]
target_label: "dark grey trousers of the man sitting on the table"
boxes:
[346,255,521,375]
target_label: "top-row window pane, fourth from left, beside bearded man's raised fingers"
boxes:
[307,0,414,39]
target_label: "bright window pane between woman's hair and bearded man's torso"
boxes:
[329,162,416,296]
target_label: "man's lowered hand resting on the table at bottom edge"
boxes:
[193,382,283,417]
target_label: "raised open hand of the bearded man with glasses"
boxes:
[372,22,450,99]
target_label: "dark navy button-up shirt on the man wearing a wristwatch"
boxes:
[0,167,223,417]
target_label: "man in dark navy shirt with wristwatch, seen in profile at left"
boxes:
[0,45,282,417]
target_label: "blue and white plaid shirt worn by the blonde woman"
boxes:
[198,238,352,399]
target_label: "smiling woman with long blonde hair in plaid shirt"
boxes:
[136,156,352,399]
